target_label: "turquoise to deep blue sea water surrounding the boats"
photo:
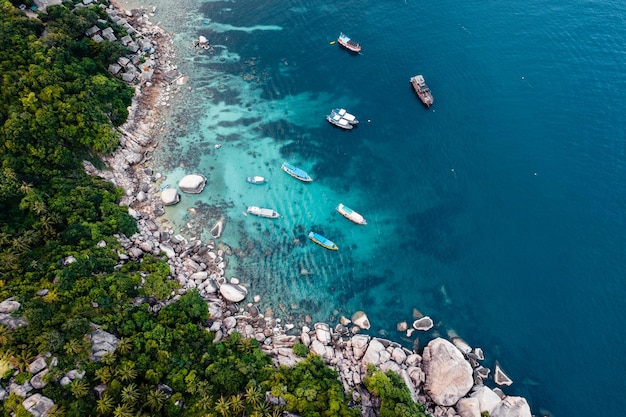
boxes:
[122,0,626,416]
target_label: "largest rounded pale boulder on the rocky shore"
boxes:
[422,338,474,407]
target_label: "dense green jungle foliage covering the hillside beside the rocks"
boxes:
[0,0,423,417]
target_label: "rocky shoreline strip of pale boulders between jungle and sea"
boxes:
[92,2,530,417]
